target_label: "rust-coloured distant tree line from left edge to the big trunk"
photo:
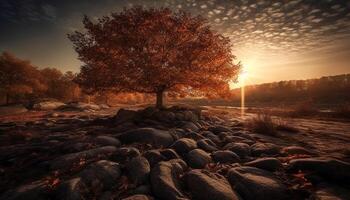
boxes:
[0,52,154,105]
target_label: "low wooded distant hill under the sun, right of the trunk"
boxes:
[176,74,350,106]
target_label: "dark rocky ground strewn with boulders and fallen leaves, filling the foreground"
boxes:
[0,106,350,200]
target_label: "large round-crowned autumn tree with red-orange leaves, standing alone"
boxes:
[68,7,240,107]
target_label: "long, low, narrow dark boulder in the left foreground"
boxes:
[50,146,117,170]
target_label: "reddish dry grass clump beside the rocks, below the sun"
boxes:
[246,113,299,137]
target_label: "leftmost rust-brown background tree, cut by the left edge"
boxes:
[0,52,45,104]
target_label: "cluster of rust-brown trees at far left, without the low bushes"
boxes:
[0,52,80,104]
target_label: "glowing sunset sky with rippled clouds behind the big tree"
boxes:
[0,0,350,84]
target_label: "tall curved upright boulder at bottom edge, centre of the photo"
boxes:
[151,159,189,200]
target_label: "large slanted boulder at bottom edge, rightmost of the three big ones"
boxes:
[228,167,288,200]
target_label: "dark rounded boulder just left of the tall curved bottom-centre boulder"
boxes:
[126,156,151,185]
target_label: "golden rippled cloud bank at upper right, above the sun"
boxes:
[135,0,350,54]
